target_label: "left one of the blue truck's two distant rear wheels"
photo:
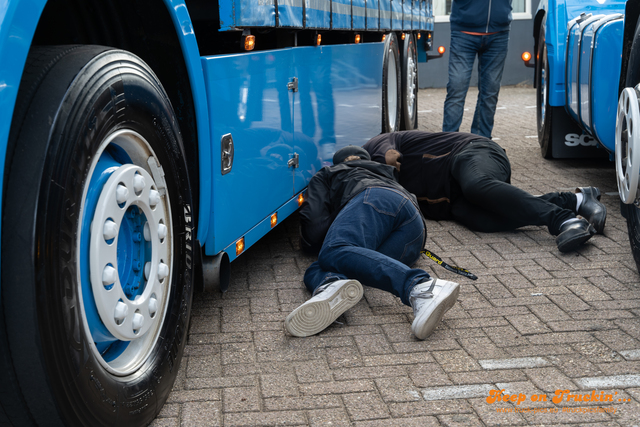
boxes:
[382,33,401,133]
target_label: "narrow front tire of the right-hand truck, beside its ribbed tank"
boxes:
[536,15,552,159]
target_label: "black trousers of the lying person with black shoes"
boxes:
[451,141,575,235]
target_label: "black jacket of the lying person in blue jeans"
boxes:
[300,160,427,253]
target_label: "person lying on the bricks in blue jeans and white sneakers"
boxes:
[285,146,459,339]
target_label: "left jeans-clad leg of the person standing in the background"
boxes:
[442,31,482,132]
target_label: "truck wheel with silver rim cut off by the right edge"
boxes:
[615,22,640,272]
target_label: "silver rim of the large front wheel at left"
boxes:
[78,129,173,376]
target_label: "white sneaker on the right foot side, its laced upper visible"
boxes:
[409,279,460,340]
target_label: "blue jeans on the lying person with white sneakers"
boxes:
[304,187,430,305]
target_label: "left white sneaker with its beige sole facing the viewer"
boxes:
[284,280,363,337]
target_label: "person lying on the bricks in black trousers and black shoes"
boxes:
[363,131,607,252]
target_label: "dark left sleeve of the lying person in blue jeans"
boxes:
[300,169,333,253]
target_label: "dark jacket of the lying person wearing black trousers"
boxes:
[363,130,486,221]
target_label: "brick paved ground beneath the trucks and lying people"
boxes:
[153,87,640,427]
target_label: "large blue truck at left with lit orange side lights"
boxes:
[0,0,434,427]
